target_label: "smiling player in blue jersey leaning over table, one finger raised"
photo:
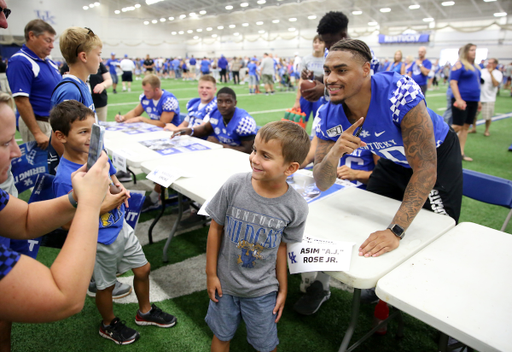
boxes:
[313,39,462,300]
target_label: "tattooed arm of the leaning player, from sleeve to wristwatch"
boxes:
[393,101,437,229]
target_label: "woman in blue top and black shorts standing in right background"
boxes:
[450,43,482,161]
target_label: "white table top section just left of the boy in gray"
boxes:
[141,148,251,204]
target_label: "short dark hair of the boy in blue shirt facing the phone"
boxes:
[50,100,94,137]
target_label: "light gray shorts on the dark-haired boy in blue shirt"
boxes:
[93,220,148,290]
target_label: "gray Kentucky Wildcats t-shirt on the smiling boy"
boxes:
[206,173,309,297]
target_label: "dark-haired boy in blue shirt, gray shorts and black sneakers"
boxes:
[50,100,176,345]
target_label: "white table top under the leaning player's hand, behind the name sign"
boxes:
[306,188,455,289]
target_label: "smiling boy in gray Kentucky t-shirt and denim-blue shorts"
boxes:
[205,121,310,352]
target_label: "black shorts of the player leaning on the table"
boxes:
[366,129,462,222]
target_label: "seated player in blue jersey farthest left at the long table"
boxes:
[116,75,181,127]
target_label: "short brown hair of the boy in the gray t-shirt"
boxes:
[258,121,311,164]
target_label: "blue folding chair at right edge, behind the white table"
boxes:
[462,169,512,231]
